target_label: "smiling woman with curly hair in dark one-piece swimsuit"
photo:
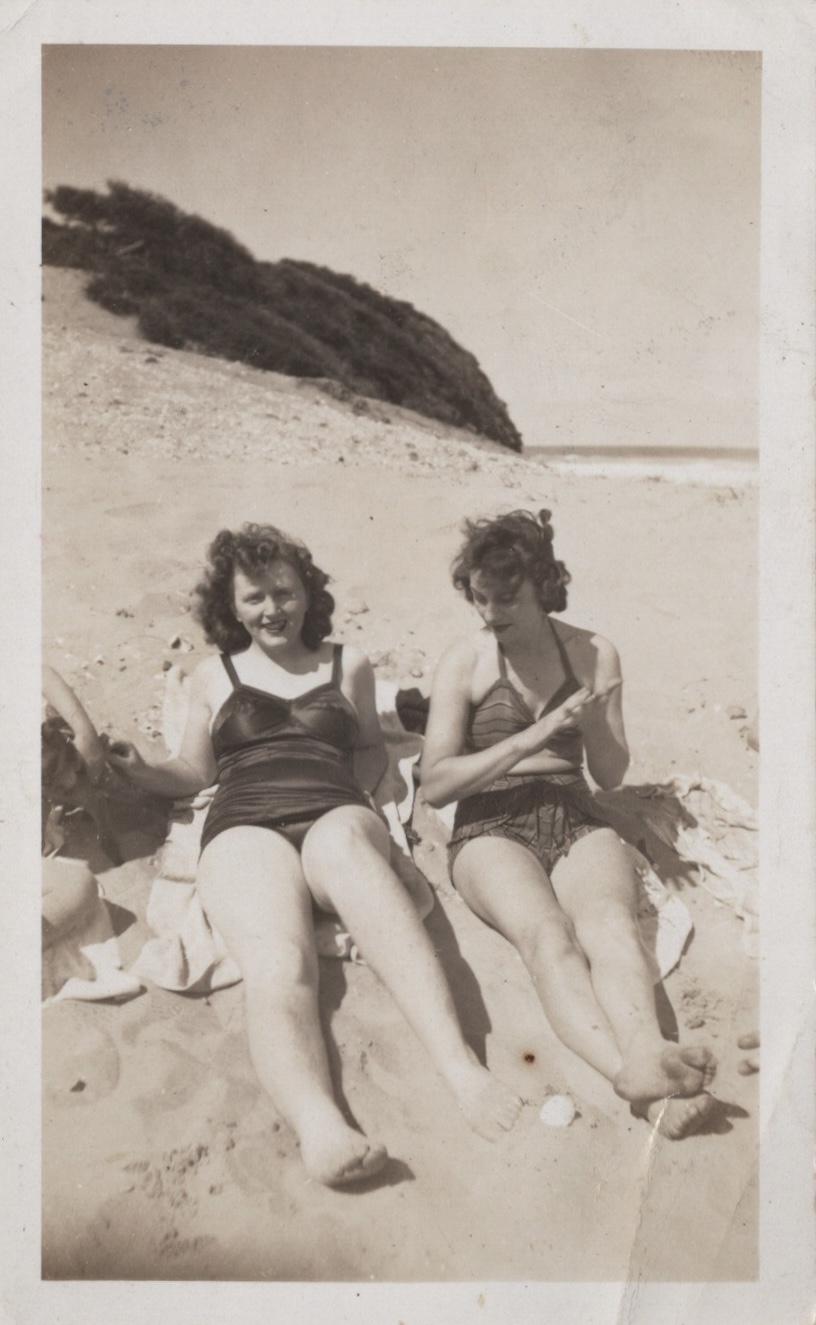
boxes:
[111,525,522,1185]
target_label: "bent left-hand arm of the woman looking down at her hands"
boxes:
[421,641,589,807]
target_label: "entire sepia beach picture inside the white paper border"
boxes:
[41,44,762,1284]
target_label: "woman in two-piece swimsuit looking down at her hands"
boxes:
[423,510,714,1138]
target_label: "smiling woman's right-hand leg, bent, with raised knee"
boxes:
[302,807,522,1140]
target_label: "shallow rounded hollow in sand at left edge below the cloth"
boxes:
[42,1018,121,1108]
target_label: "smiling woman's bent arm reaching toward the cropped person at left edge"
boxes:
[109,659,216,799]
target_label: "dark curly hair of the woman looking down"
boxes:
[450,510,570,612]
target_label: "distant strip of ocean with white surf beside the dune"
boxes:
[523,447,759,488]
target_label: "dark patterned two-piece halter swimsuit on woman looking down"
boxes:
[448,619,608,875]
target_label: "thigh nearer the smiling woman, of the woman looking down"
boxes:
[453,836,574,947]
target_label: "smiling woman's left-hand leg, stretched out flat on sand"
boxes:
[197,827,388,1186]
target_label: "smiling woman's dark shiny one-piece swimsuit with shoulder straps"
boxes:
[201,644,370,851]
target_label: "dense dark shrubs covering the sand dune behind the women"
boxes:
[42,182,522,451]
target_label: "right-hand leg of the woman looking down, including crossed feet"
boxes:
[552,828,715,1137]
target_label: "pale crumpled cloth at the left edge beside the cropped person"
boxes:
[41,857,142,1007]
